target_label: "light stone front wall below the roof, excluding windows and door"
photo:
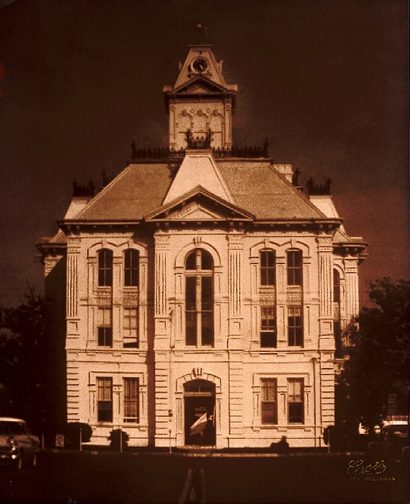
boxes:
[58,225,357,447]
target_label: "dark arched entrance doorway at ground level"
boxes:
[184,379,216,446]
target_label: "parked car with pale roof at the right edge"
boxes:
[367,421,409,460]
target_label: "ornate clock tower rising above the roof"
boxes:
[163,44,238,150]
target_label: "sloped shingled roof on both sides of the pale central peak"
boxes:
[66,159,327,222]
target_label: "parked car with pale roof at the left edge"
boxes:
[0,417,40,469]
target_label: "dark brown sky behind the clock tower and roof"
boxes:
[0,0,408,305]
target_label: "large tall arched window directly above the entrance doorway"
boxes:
[185,249,214,346]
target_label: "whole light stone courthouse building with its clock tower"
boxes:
[39,45,366,448]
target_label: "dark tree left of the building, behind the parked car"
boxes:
[0,289,64,429]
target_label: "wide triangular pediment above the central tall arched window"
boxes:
[145,186,254,222]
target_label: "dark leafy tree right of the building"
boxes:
[341,278,410,426]
